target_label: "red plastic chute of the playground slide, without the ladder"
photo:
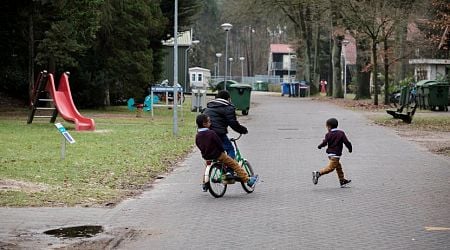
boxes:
[47,73,95,131]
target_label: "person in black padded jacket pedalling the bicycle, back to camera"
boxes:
[203,90,248,159]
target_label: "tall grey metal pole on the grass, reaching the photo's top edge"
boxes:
[173,0,178,136]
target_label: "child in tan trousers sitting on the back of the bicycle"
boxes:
[195,114,258,192]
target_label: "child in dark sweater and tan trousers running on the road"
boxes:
[313,118,352,187]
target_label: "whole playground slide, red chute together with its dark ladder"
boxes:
[27,71,95,131]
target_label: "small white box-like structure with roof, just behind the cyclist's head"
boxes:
[189,67,211,112]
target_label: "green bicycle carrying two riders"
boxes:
[203,135,255,198]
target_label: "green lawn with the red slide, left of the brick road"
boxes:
[0,102,196,207]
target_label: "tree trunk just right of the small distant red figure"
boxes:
[331,35,344,98]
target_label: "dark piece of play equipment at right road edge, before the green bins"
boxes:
[386,86,417,124]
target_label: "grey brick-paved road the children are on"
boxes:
[0,93,450,250]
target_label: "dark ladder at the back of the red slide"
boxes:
[27,71,58,124]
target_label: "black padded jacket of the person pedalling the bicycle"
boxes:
[203,98,248,136]
